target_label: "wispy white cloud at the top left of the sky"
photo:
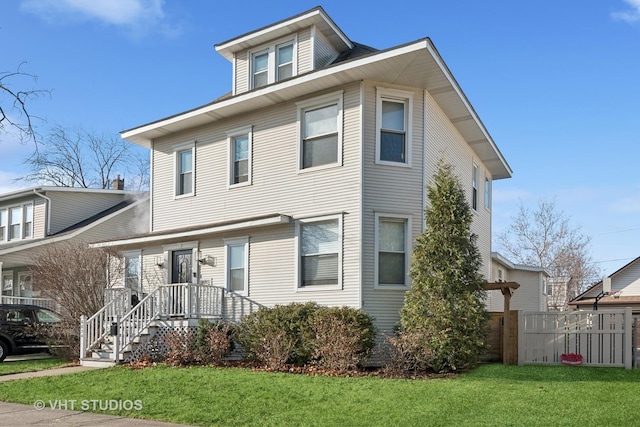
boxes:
[22,0,177,35]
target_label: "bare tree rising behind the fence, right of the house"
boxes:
[496,200,601,310]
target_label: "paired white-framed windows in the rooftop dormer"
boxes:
[250,39,296,89]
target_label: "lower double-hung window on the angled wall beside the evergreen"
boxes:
[375,213,411,288]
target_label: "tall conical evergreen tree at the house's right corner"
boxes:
[400,160,488,372]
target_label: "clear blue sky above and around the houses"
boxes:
[0,0,640,274]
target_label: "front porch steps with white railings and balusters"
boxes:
[80,283,262,366]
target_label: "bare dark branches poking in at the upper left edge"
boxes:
[0,62,49,142]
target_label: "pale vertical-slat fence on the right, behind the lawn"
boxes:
[518,308,633,369]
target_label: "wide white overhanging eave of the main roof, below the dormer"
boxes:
[121,39,513,180]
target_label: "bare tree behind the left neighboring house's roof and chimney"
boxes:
[20,126,149,190]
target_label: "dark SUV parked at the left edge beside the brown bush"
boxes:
[0,304,60,362]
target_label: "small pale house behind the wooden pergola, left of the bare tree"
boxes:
[486,252,549,312]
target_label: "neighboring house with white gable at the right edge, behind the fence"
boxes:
[569,257,640,315]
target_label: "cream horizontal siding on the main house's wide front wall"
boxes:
[152,83,361,306]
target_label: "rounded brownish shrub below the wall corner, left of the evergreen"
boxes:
[311,307,376,371]
